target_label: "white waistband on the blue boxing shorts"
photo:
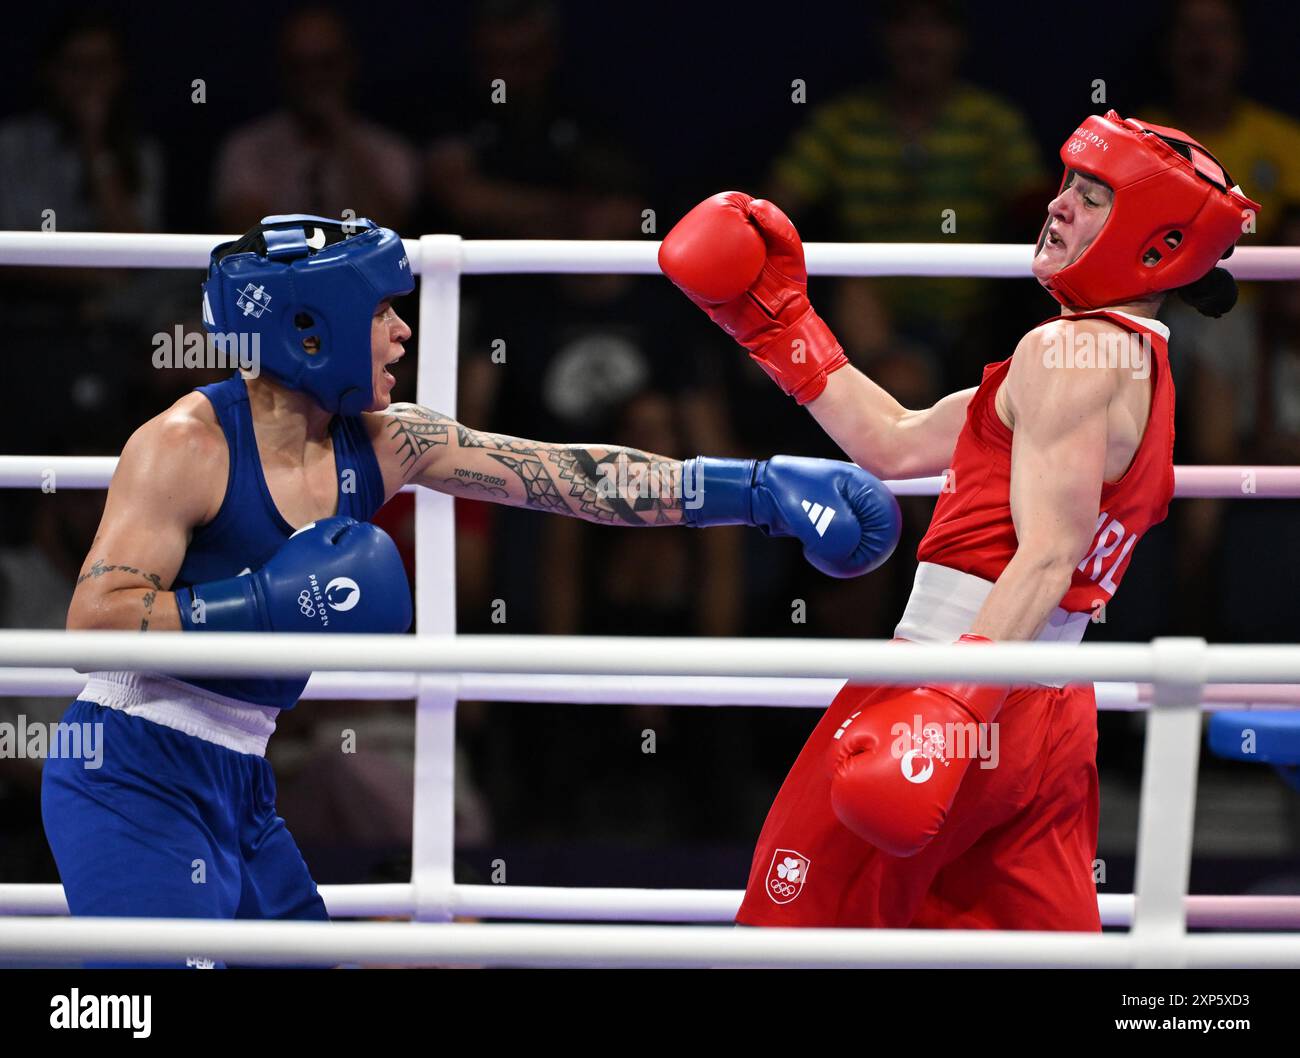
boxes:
[77,672,280,756]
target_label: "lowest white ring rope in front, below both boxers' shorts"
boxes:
[0,918,1300,968]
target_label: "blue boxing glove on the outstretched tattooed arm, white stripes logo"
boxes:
[681,455,902,577]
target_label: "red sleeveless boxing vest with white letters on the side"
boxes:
[917,312,1174,613]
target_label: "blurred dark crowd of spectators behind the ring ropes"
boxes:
[0,0,1300,883]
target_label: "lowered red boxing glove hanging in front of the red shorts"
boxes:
[827,634,1009,857]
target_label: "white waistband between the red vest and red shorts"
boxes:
[894,561,1092,686]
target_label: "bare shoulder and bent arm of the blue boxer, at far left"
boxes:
[68,408,228,632]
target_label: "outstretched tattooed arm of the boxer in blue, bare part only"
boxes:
[371,404,683,525]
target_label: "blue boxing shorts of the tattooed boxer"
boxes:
[40,673,329,966]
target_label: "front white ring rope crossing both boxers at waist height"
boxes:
[0,632,1300,681]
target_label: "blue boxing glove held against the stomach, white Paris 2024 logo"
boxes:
[176,516,411,632]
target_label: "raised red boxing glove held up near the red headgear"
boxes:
[659,191,849,404]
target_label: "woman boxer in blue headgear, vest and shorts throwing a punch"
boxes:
[42,214,898,967]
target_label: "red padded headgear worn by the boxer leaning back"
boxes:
[1039,110,1260,308]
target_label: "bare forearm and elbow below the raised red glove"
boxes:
[807,364,975,478]
